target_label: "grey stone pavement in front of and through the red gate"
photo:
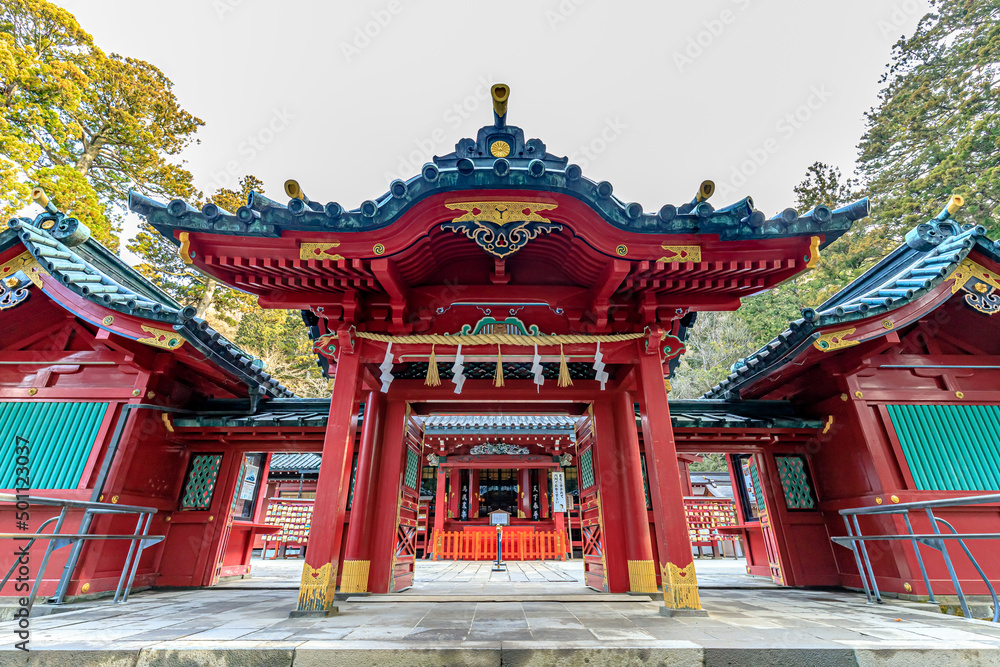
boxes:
[0,563,1000,667]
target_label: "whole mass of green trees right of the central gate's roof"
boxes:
[674,0,1000,390]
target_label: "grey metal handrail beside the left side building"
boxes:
[0,493,166,613]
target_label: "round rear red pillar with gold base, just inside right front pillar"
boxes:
[614,392,660,593]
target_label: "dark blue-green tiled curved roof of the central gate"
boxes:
[129,118,868,246]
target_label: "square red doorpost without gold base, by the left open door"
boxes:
[368,399,409,593]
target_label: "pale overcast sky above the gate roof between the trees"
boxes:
[57,0,927,260]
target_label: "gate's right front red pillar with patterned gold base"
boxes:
[638,336,705,615]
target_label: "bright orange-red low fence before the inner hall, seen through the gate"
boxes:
[434,530,567,560]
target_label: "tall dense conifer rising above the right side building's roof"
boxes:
[858,0,1000,252]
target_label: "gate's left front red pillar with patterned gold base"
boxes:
[292,341,364,616]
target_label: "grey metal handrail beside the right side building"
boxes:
[830,493,1000,623]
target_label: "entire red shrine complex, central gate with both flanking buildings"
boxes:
[0,84,1000,615]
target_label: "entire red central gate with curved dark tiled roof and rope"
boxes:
[130,84,868,614]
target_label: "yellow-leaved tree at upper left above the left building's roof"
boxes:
[0,0,203,250]
